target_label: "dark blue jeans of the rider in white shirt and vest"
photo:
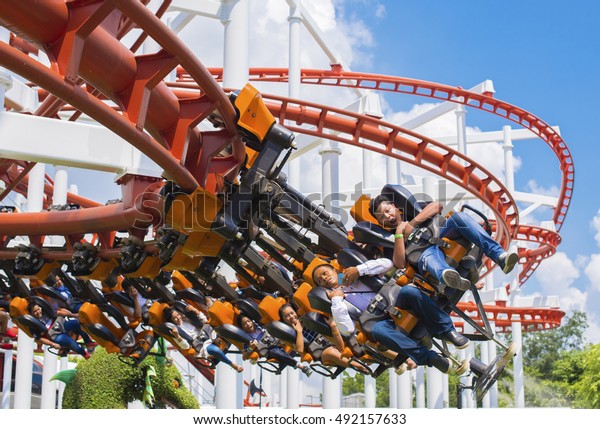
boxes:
[371,286,454,365]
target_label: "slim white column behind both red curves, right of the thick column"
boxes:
[288,0,302,189]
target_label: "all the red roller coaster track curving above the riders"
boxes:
[0,0,574,328]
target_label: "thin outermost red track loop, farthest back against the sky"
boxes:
[178,66,574,285]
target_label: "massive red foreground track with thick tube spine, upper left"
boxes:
[0,0,245,241]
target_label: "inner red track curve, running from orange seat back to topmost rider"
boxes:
[263,94,518,245]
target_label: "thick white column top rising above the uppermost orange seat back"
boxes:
[221,0,250,89]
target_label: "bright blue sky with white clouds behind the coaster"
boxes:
[48,0,600,342]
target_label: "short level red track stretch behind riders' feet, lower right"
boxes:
[454,302,565,333]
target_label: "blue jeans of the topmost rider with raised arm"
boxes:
[418,212,504,282]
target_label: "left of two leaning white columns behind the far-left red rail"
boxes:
[15,163,46,409]
